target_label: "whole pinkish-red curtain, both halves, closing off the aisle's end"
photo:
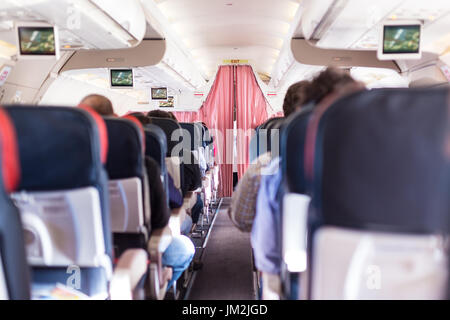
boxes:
[174,66,272,197]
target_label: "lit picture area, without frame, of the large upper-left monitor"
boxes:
[18,27,56,56]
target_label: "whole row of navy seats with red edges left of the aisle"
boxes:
[0,106,218,299]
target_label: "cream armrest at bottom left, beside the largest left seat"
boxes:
[109,249,148,300]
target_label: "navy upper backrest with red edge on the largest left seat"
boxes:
[5,106,107,191]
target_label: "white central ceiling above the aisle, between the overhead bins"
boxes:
[154,0,300,77]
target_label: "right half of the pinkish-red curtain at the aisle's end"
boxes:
[236,66,268,179]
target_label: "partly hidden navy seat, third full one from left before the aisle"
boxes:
[144,124,169,204]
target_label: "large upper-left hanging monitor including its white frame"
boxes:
[17,23,59,59]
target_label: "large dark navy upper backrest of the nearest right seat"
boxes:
[308,89,450,233]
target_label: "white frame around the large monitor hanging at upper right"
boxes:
[377,20,423,60]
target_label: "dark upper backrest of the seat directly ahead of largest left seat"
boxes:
[104,117,144,179]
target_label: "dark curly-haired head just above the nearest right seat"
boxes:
[306,67,365,103]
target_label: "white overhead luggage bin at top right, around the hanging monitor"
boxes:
[293,0,450,53]
